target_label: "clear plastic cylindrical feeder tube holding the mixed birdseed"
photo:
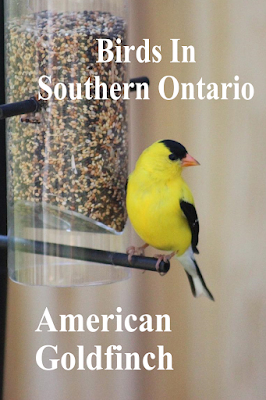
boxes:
[6,0,130,286]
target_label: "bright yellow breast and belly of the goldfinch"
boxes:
[127,177,191,254]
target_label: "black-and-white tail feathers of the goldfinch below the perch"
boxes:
[177,247,214,301]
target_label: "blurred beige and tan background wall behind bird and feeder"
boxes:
[5,0,266,400]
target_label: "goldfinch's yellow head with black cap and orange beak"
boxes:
[137,140,199,177]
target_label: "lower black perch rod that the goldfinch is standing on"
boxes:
[0,235,170,274]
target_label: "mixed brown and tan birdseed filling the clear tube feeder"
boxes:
[6,11,128,232]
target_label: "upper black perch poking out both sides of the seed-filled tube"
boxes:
[0,76,150,119]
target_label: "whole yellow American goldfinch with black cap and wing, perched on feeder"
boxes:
[126,140,214,300]
